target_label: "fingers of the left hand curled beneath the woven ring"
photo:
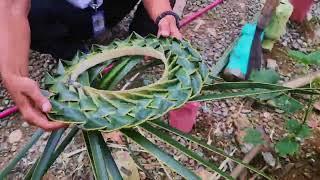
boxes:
[21,106,66,131]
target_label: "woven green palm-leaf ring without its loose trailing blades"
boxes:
[45,33,208,132]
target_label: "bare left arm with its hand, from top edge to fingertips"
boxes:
[0,0,62,130]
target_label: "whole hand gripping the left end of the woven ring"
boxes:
[3,76,66,131]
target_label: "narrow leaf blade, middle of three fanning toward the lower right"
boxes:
[140,123,233,179]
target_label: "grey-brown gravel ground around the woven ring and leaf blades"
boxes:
[0,0,320,179]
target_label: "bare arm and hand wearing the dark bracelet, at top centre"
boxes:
[143,0,182,39]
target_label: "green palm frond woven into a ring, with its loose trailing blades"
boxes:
[0,34,319,180]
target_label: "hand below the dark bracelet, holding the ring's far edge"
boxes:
[158,15,182,39]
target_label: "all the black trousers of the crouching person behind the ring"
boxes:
[29,0,173,60]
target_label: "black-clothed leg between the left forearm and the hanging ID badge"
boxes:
[28,0,90,60]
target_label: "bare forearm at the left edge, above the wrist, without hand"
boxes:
[0,0,30,80]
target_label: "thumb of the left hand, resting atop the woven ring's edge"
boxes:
[23,78,52,113]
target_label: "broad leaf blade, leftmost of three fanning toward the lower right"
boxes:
[121,129,200,179]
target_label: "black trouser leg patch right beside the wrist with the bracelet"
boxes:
[130,0,176,36]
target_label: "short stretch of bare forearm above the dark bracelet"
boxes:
[143,0,172,21]
